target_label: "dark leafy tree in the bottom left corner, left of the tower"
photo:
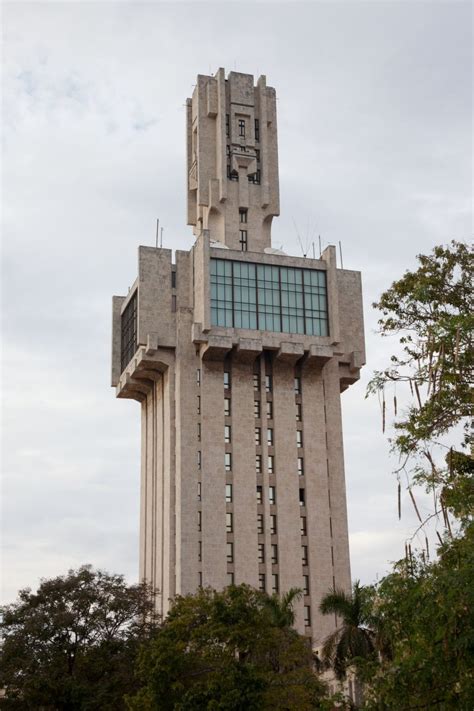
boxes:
[0,566,156,711]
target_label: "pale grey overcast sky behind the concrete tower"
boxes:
[2,0,472,601]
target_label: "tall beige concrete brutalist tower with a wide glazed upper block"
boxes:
[112,69,364,644]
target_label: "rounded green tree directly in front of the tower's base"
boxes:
[128,585,330,711]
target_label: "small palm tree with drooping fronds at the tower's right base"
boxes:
[319,580,377,681]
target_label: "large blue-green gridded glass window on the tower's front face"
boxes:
[210,258,328,336]
